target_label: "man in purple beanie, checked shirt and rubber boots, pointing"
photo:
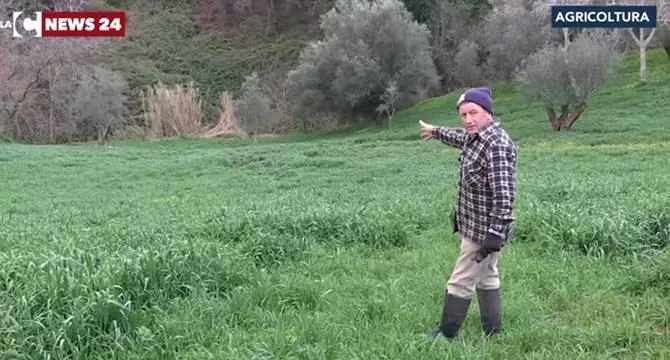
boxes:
[420,88,516,339]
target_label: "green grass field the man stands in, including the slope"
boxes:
[0,52,670,360]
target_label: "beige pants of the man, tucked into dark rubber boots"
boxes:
[447,238,502,299]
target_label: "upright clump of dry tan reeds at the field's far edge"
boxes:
[142,82,203,138]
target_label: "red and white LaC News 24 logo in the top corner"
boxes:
[0,11,126,38]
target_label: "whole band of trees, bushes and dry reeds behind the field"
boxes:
[0,0,670,143]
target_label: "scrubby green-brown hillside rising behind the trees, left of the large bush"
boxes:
[103,0,322,120]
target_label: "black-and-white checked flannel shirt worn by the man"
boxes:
[433,119,516,244]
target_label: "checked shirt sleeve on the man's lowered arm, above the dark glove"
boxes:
[487,140,516,239]
